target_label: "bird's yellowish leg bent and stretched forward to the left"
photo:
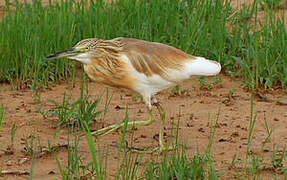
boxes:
[92,108,153,136]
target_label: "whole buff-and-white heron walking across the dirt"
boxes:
[46,37,221,153]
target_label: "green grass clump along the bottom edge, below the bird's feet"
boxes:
[54,106,217,180]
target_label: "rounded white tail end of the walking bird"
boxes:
[188,57,221,76]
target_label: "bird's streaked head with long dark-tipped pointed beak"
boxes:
[46,38,100,64]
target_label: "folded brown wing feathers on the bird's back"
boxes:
[114,38,194,78]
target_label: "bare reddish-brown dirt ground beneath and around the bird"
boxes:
[0,76,287,179]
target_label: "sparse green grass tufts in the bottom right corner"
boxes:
[230,93,287,179]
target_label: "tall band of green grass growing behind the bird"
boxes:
[0,0,287,88]
